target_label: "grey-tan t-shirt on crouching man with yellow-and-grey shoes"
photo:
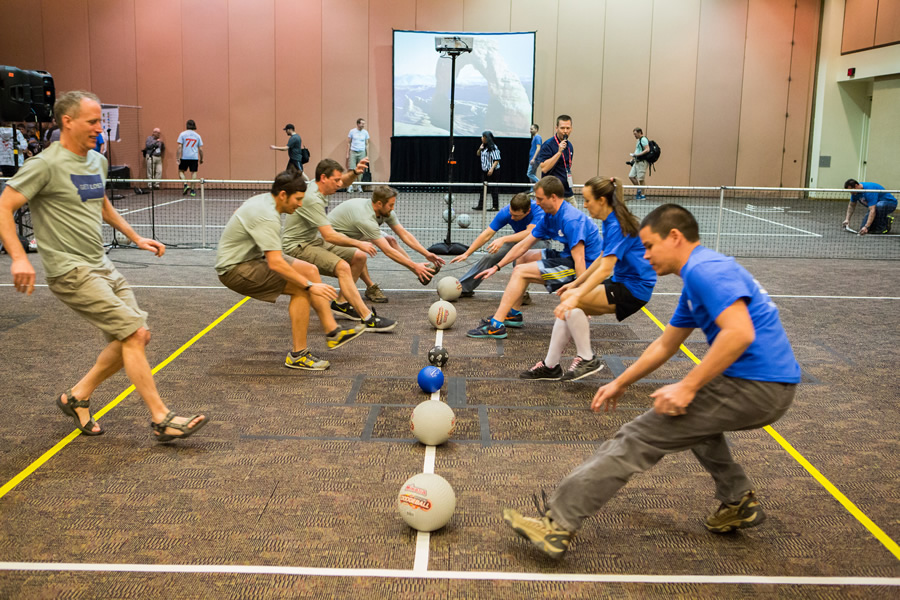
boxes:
[216,193,281,275]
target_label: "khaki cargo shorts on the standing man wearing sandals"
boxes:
[47,266,147,342]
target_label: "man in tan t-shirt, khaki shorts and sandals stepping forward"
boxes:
[0,92,209,442]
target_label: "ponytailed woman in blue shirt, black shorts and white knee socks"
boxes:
[520,177,656,381]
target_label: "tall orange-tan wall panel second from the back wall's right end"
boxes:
[735,0,794,186]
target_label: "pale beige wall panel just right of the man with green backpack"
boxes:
[648,0,700,185]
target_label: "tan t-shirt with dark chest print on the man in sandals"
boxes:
[9,142,112,277]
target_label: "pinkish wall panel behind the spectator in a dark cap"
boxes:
[274,0,322,177]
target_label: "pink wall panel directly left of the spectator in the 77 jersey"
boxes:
[132,0,185,179]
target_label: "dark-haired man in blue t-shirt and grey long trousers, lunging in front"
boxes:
[503,204,800,558]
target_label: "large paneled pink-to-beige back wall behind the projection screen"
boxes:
[0,0,819,185]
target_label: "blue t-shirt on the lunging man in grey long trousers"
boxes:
[669,246,800,383]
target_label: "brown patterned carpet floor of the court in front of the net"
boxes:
[0,250,900,598]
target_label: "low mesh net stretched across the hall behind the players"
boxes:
[3,179,900,259]
